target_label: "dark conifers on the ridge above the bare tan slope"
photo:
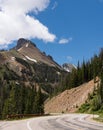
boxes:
[58,49,103,90]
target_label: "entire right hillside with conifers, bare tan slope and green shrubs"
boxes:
[45,49,103,113]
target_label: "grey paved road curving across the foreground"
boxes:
[0,114,103,130]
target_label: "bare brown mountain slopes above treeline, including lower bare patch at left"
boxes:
[0,38,62,74]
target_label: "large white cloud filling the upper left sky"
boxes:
[0,0,56,47]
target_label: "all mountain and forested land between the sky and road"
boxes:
[0,38,103,119]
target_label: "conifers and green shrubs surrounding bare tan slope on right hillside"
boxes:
[64,48,103,113]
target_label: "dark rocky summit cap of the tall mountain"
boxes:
[14,38,36,50]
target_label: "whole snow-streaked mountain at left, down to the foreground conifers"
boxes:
[0,38,66,93]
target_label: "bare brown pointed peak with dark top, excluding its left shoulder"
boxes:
[10,38,60,67]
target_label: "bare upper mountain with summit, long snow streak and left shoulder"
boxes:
[0,38,61,68]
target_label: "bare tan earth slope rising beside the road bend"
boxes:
[45,77,97,113]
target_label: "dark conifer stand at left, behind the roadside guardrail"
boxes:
[0,81,44,119]
